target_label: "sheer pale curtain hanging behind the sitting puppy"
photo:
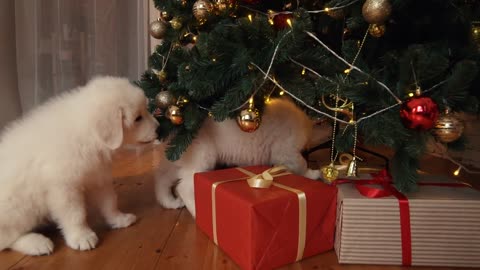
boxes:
[15,0,151,112]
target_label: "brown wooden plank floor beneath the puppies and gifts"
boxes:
[0,142,476,270]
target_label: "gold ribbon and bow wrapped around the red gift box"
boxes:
[212,166,307,261]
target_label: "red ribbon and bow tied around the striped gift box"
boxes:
[334,169,471,266]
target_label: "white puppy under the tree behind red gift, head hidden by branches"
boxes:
[155,98,320,216]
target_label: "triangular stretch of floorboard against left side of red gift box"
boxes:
[155,209,239,270]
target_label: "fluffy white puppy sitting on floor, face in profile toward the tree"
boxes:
[0,77,158,255]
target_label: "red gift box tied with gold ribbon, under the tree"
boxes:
[194,166,337,269]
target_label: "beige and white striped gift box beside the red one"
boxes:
[335,175,480,267]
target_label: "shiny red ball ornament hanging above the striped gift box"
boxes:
[400,96,438,131]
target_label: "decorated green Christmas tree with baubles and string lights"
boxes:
[138,0,480,192]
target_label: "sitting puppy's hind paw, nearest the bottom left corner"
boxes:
[10,233,53,256]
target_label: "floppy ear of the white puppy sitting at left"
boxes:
[96,108,123,150]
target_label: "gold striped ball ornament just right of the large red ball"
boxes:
[433,111,465,143]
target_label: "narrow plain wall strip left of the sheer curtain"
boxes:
[0,0,21,129]
